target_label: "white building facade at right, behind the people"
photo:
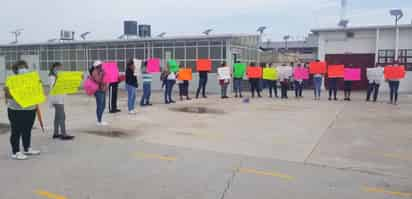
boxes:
[312,25,412,92]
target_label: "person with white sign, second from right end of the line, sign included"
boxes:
[366,65,383,102]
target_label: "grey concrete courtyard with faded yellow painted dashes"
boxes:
[0,91,412,199]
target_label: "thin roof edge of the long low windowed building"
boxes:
[0,34,259,48]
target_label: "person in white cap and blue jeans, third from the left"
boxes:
[89,61,108,126]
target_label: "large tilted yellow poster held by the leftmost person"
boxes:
[6,72,46,108]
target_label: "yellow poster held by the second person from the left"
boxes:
[50,72,83,95]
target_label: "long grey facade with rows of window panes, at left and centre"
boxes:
[0,35,259,92]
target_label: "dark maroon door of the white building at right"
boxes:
[326,54,375,90]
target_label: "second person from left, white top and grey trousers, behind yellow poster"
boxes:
[49,62,74,140]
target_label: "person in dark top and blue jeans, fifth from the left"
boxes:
[126,59,138,115]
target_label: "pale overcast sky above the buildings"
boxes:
[0,0,412,44]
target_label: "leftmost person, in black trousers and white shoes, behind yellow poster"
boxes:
[4,61,40,160]
